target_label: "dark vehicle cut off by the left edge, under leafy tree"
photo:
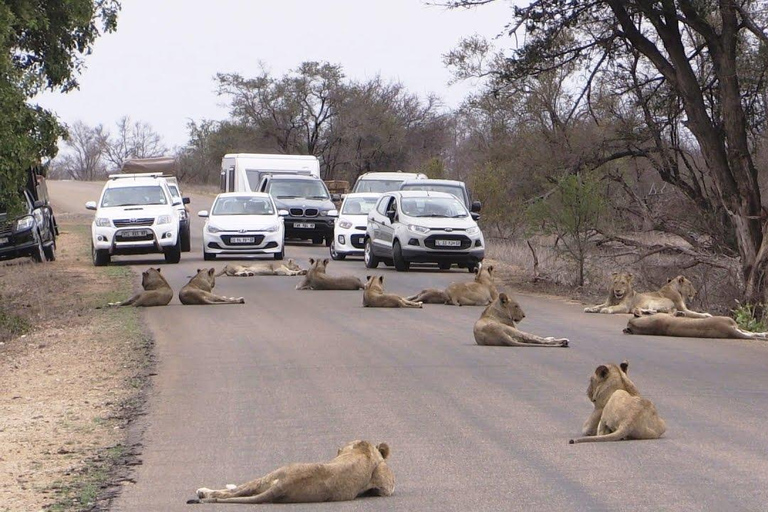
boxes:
[0,168,59,263]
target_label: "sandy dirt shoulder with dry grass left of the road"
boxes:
[0,216,152,512]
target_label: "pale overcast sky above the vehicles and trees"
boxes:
[37,0,512,147]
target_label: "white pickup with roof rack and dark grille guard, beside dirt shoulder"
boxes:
[85,173,182,266]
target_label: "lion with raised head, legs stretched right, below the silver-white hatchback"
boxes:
[474,293,568,347]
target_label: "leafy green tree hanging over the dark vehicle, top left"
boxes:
[0,0,120,214]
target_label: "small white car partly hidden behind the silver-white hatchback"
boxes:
[330,192,381,260]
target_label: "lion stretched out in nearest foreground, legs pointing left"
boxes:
[187,441,395,504]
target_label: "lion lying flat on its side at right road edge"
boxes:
[624,313,768,340]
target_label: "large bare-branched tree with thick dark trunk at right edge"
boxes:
[451,0,768,303]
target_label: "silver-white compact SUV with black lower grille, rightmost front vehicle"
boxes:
[365,190,485,272]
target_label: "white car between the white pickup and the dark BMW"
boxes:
[198,192,288,260]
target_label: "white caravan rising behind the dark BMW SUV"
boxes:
[221,153,320,192]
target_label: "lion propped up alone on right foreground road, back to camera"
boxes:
[569,361,667,444]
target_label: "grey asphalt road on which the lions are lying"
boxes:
[50,182,768,511]
